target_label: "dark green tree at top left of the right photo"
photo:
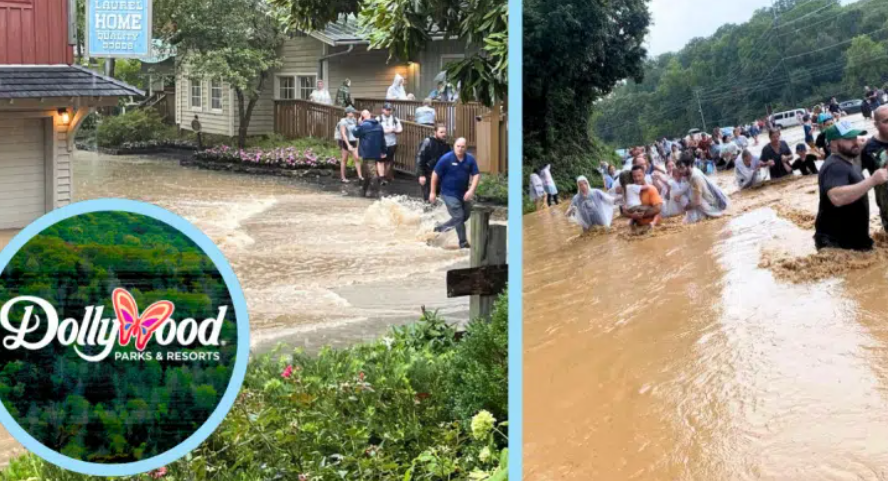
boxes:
[523,0,650,195]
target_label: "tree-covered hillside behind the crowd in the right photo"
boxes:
[594,0,888,146]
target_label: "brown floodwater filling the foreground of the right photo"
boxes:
[524,113,888,481]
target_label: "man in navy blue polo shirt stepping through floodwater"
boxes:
[429,137,481,249]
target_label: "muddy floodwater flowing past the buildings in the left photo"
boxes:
[0,151,492,466]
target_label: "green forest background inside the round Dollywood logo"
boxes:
[0,212,237,463]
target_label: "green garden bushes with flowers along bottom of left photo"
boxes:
[0,295,508,481]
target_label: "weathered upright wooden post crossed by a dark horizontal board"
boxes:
[469,207,506,319]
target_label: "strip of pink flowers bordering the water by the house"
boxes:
[194,145,339,170]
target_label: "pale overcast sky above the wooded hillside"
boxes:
[647,0,850,57]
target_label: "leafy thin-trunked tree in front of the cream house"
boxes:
[155,0,284,148]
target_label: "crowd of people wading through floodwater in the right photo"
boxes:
[552,91,888,255]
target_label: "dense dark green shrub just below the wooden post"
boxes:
[449,294,509,419]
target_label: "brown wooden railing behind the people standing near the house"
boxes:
[274,100,435,174]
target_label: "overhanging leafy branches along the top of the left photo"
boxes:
[272,0,509,105]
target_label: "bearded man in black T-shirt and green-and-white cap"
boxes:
[814,121,888,250]
